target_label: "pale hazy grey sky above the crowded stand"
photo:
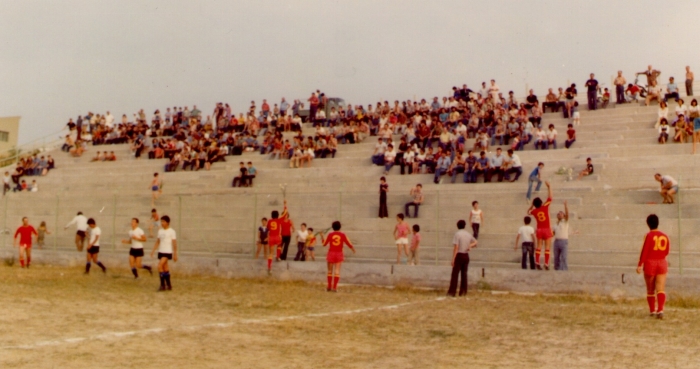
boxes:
[0,0,700,143]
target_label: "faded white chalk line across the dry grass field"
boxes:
[0,297,446,350]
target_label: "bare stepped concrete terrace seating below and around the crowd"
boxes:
[5,100,700,273]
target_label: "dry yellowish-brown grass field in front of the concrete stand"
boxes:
[0,265,700,368]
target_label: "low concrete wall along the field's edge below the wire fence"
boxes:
[8,250,700,298]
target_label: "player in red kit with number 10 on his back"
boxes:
[637,214,671,319]
